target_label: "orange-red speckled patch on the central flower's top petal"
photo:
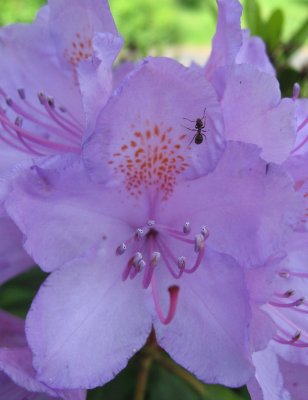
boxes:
[108,121,191,200]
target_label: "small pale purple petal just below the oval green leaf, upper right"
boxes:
[235,30,276,76]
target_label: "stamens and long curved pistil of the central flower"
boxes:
[116,220,209,324]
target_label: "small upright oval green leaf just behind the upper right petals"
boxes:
[263,9,284,52]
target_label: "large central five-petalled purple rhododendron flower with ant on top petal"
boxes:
[6,58,302,388]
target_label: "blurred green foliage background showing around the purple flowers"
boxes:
[0,0,308,400]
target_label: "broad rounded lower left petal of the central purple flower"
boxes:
[27,246,151,388]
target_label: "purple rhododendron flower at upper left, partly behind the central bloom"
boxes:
[0,0,121,282]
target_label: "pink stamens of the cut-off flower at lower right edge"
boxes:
[265,270,308,348]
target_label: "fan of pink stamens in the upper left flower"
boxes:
[0,88,83,156]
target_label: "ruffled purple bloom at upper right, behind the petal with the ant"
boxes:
[204,0,296,163]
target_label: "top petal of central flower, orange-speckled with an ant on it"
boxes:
[85,58,224,183]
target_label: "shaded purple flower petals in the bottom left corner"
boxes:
[0,311,86,400]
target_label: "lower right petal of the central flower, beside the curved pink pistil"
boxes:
[154,247,253,386]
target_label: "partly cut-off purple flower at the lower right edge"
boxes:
[247,232,308,400]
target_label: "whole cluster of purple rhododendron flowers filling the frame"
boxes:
[0,0,308,400]
